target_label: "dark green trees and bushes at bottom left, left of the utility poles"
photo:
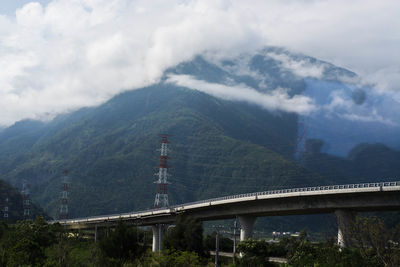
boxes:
[0,217,216,267]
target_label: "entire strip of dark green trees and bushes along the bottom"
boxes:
[0,217,400,267]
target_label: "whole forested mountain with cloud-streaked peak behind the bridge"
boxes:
[0,48,400,227]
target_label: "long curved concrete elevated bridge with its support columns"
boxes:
[53,182,400,251]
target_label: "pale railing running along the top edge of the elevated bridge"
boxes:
[57,181,400,224]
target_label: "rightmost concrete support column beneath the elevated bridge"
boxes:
[335,210,356,248]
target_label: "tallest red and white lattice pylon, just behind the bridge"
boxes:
[154,134,169,208]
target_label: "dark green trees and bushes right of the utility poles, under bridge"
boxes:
[234,217,400,267]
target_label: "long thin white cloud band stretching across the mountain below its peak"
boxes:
[166,75,317,115]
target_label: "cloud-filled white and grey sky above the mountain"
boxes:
[0,0,400,126]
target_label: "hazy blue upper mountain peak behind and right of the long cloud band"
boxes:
[166,47,400,157]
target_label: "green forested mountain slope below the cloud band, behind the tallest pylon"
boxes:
[0,84,328,217]
